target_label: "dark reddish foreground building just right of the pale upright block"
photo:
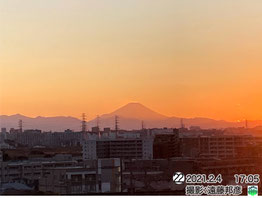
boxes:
[122,158,194,194]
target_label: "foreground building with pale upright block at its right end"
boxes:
[39,159,121,195]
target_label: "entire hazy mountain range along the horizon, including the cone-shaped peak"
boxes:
[0,103,262,132]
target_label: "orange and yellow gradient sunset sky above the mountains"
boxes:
[0,0,262,121]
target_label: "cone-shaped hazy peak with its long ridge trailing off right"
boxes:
[88,103,262,129]
